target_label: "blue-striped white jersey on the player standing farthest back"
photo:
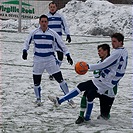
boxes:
[47,12,70,36]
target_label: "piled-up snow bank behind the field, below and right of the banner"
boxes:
[0,0,133,37]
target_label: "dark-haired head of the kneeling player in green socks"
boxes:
[97,44,110,60]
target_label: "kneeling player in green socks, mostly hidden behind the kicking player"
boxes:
[75,44,117,124]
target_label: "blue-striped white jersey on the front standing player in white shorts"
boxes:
[24,27,69,60]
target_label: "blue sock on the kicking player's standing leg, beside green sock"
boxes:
[85,101,93,121]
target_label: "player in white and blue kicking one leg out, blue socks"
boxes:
[49,33,128,121]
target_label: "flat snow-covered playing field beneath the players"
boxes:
[0,32,133,133]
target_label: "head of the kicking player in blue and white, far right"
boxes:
[111,33,124,49]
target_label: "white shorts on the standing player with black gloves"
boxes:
[33,59,60,75]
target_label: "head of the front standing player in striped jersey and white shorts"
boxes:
[39,15,48,31]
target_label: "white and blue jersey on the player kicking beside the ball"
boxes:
[89,47,128,94]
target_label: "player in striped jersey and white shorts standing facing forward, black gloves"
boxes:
[22,15,73,106]
